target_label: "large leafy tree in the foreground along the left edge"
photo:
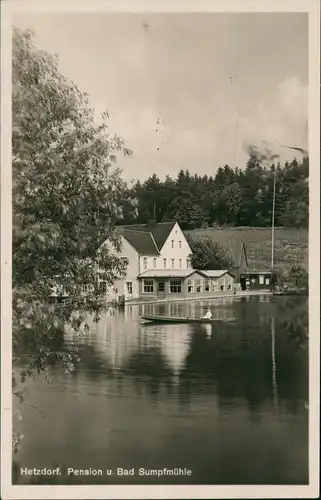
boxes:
[12,29,130,420]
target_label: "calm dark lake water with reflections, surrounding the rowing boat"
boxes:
[15,297,308,484]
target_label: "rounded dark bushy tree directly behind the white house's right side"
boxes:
[189,236,236,270]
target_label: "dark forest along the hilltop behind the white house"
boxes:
[120,156,309,229]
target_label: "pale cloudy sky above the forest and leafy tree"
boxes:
[13,12,308,180]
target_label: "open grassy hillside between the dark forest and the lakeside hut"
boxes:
[185,227,308,269]
